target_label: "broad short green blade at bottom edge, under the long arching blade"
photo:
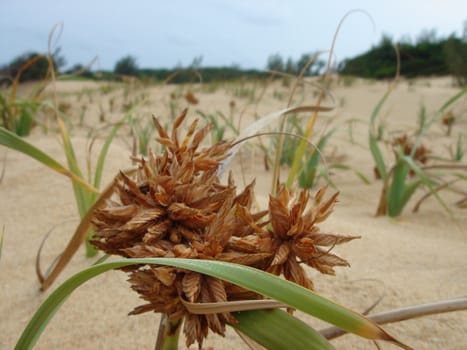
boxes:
[231,309,334,350]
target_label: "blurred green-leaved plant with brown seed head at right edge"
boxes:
[368,84,467,217]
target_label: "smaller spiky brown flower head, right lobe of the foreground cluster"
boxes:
[266,186,358,289]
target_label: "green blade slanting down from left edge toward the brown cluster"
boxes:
[0,127,97,192]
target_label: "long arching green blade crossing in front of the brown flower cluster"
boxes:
[15,258,410,350]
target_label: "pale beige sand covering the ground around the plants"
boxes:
[0,78,467,350]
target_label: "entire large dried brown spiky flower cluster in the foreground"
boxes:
[93,112,362,347]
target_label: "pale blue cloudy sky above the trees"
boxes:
[0,0,467,70]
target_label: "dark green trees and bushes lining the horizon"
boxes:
[0,22,467,85]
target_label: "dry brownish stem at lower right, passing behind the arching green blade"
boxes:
[320,297,467,339]
